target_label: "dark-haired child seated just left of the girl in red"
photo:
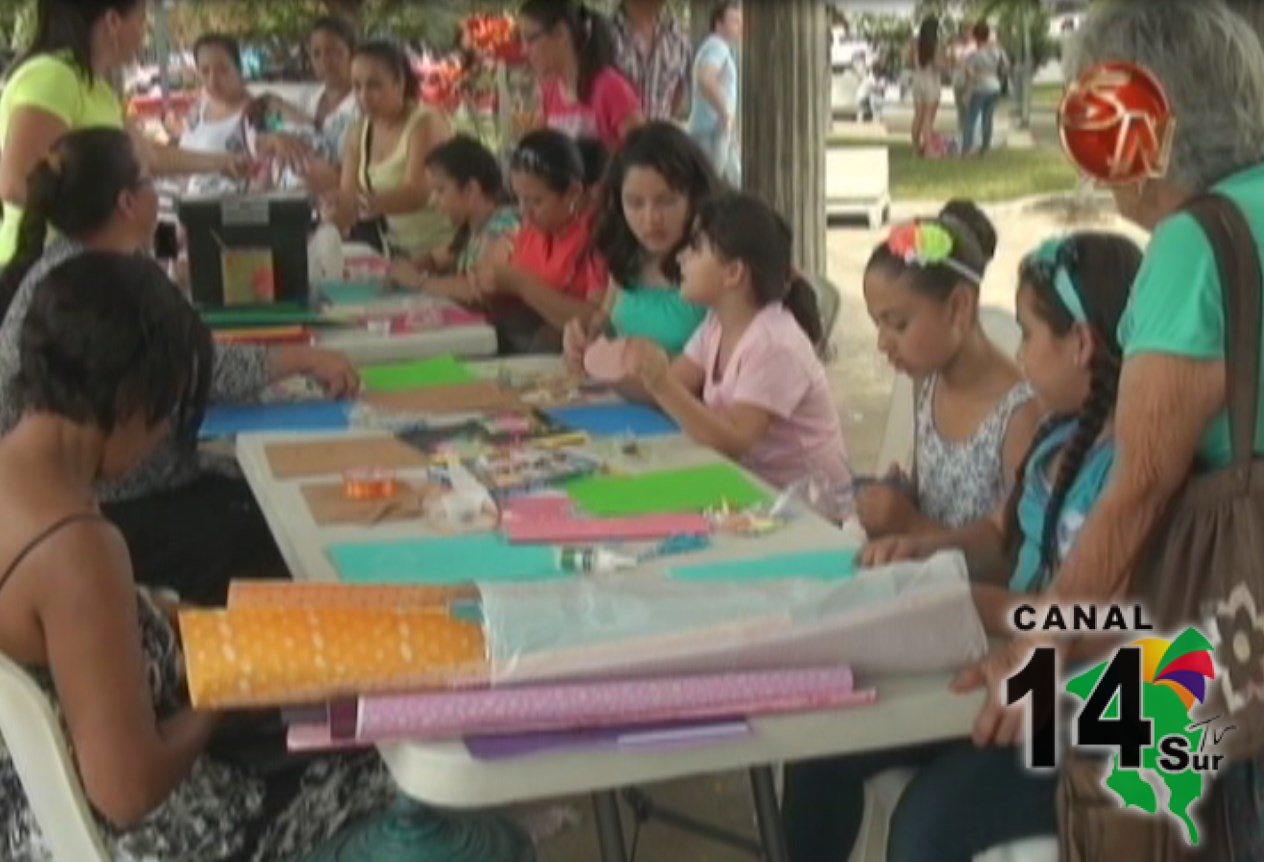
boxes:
[391,135,518,305]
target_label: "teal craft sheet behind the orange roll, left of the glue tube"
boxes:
[327,530,568,584]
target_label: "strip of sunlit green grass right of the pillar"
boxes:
[830,139,1076,202]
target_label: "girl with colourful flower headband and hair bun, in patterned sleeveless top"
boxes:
[856,201,1040,538]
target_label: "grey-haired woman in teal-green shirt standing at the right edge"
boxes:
[962,0,1264,858]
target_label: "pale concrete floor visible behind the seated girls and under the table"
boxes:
[530,203,1144,862]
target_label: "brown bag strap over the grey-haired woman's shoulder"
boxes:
[1186,193,1264,479]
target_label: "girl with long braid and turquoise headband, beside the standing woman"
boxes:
[782,233,1141,862]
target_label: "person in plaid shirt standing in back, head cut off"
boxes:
[612,0,693,120]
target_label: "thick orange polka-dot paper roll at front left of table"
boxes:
[179,608,488,708]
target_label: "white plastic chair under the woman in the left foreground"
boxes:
[0,655,110,862]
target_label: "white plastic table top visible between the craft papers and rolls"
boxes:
[238,359,983,808]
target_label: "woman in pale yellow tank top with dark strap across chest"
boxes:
[322,42,453,257]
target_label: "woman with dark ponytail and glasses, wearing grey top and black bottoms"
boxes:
[0,128,358,603]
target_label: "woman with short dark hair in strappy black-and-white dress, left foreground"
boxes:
[0,252,533,862]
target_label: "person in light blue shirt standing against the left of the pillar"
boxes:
[689,0,742,187]
